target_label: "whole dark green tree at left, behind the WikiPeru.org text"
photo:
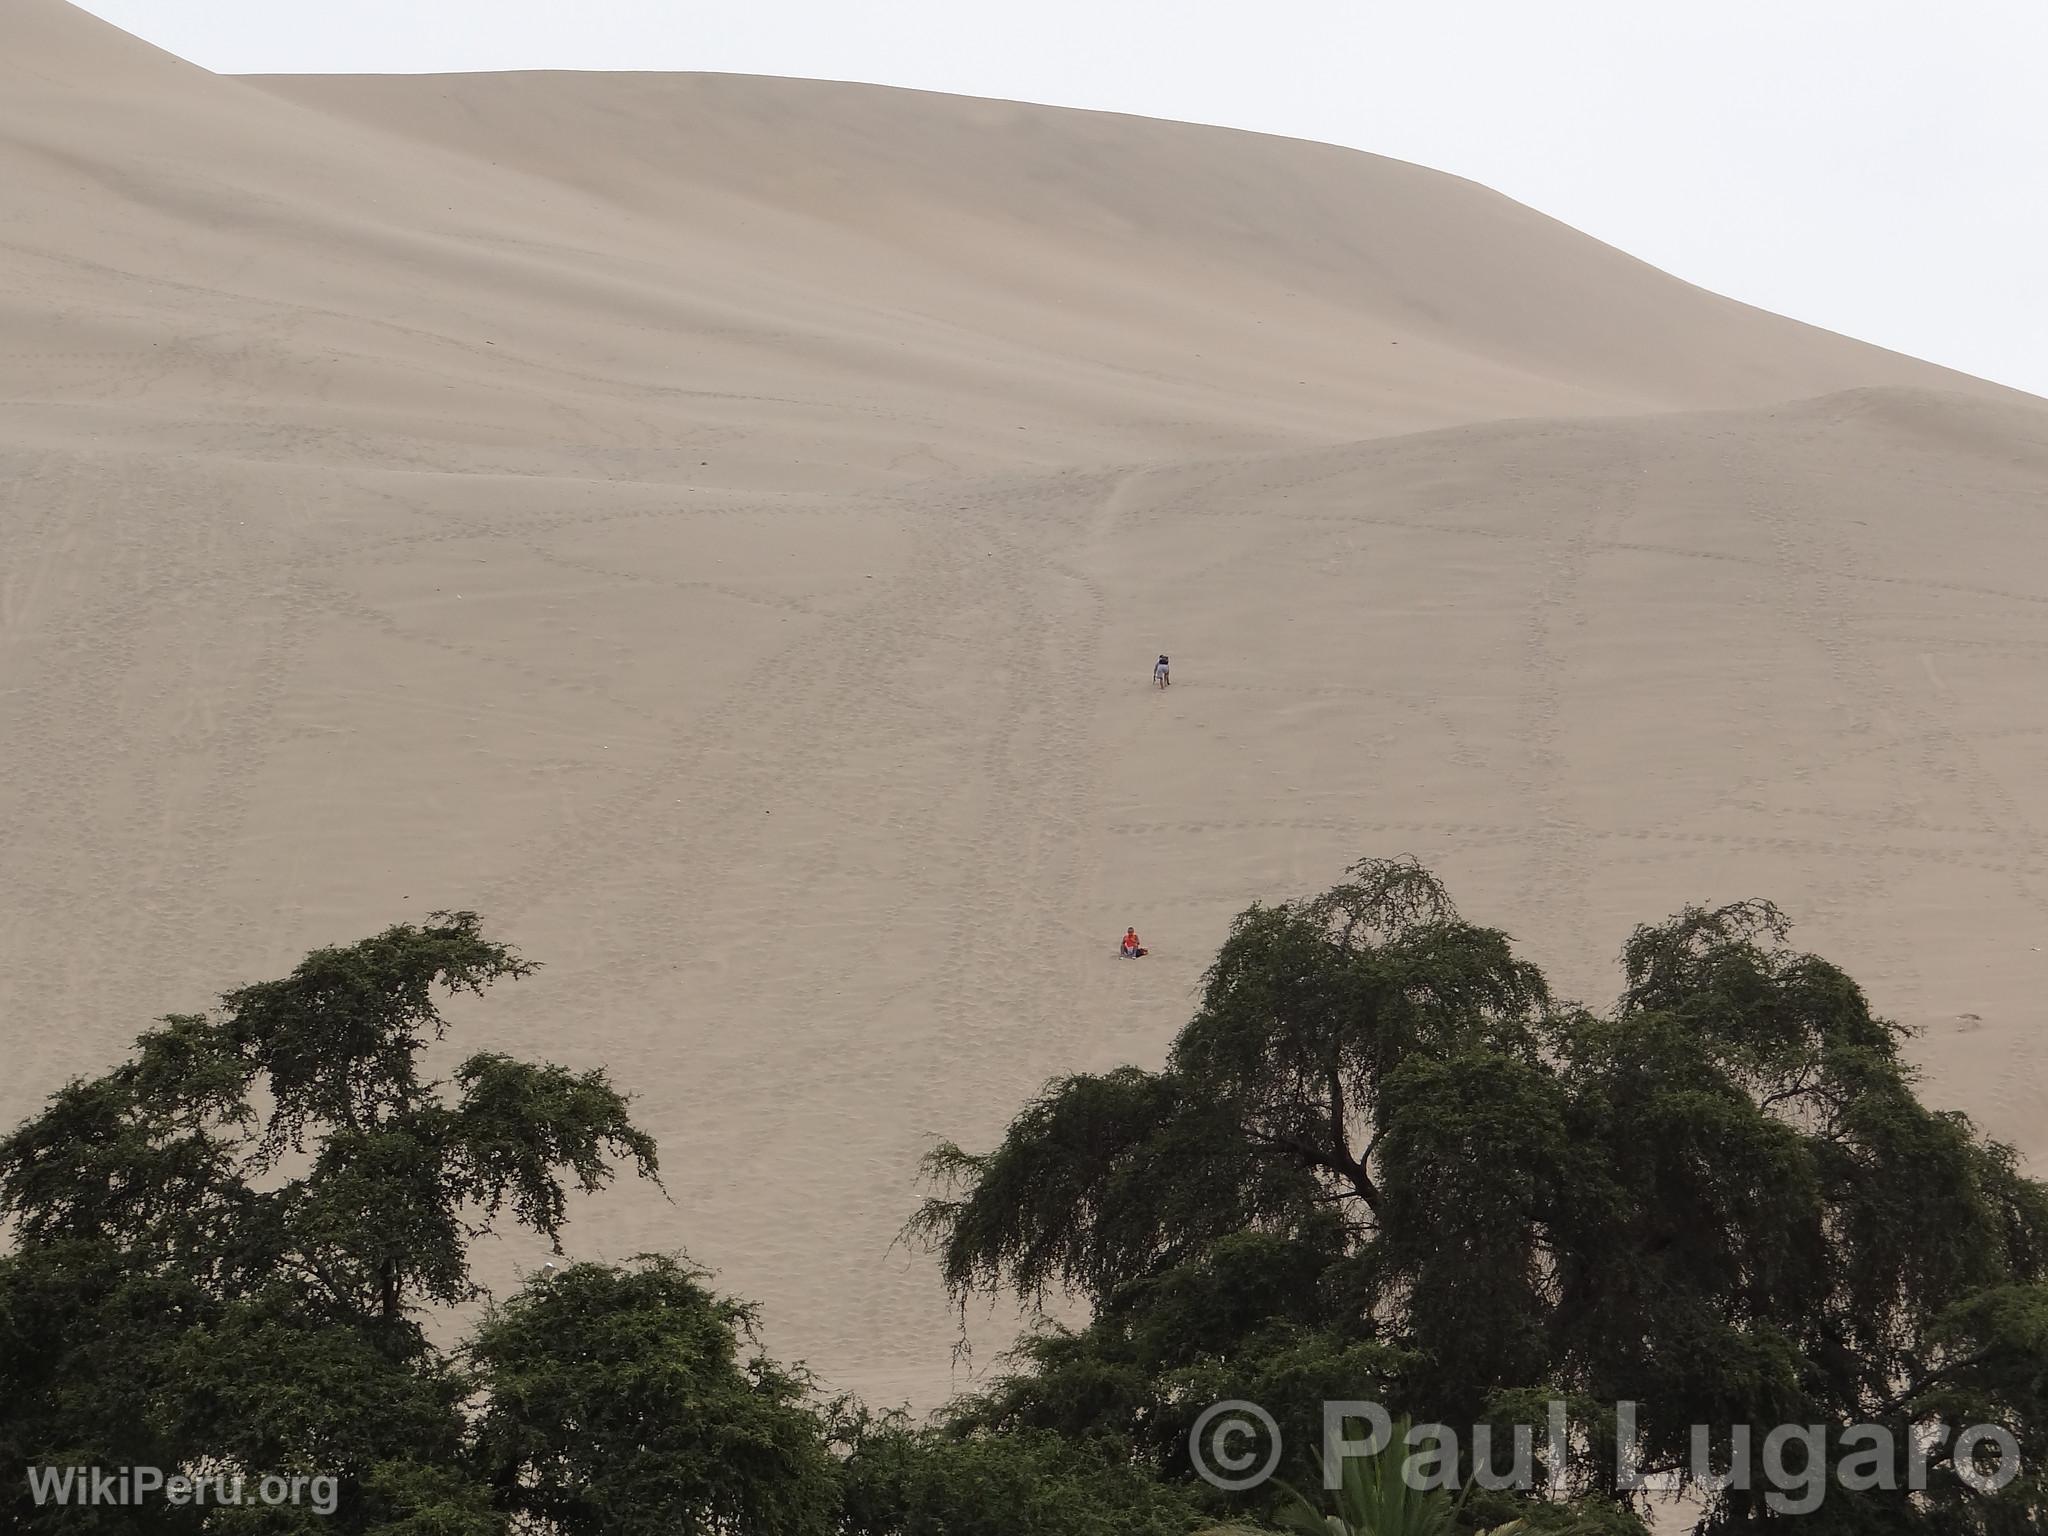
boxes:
[0,913,655,1536]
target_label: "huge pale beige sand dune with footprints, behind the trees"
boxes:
[0,0,2048,1401]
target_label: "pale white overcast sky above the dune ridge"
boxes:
[86,0,2048,395]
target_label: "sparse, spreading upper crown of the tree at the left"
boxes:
[0,911,655,1329]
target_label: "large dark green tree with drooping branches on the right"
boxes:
[913,860,2048,1532]
